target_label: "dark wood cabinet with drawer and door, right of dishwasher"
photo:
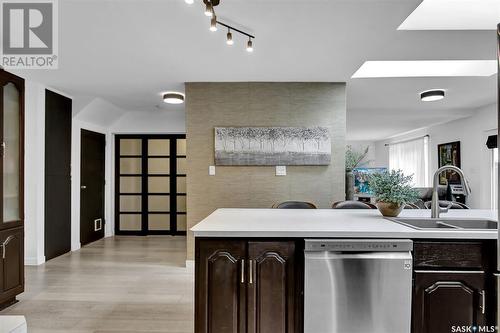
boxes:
[412,240,496,333]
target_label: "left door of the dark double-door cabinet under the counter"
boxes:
[195,240,246,333]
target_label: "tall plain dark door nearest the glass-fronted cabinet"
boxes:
[45,90,72,260]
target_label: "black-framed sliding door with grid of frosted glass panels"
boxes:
[116,135,186,235]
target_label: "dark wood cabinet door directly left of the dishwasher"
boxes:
[248,242,296,333]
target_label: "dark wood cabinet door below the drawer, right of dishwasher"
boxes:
[413,271,486,333]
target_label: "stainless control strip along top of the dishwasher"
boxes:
[305,239,413,252]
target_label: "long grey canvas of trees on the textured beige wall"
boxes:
[215,127,332,165]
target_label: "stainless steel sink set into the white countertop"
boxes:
[389,217,498,230]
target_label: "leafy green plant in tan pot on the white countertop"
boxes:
[370,170,419,217]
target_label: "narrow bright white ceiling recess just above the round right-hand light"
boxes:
[352,60,497,79]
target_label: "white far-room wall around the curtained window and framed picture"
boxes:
[375,104,497,209]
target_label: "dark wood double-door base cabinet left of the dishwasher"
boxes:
[195,239,300,333]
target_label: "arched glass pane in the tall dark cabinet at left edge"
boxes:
[2,83,21,223]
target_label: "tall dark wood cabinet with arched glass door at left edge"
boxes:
[0,70,24,309]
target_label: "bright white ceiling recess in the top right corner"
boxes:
[398,0,500,30]
